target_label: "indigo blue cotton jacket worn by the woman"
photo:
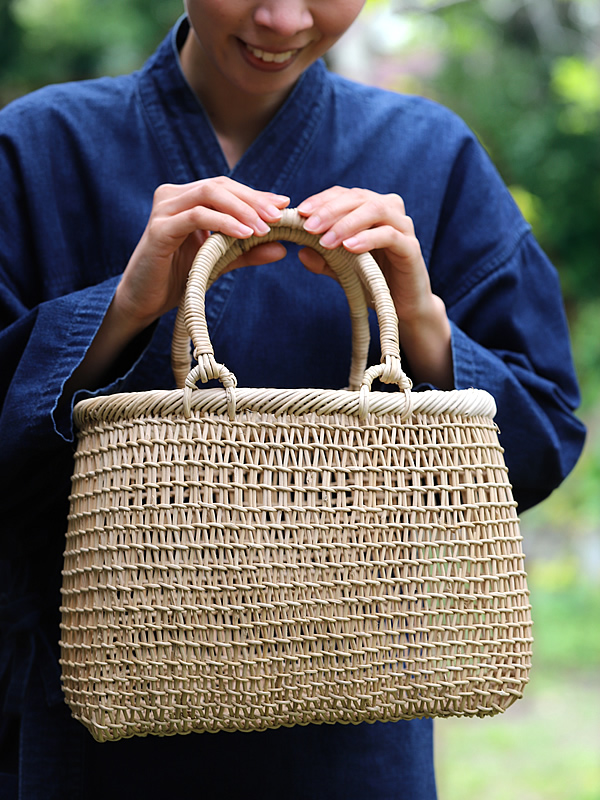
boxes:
[0,21,584,799]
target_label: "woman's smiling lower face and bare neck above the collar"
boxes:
[181,0,364,166]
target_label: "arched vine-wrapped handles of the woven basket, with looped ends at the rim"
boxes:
[171,209,412,419]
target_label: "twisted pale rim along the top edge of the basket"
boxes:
[73,388,496,427]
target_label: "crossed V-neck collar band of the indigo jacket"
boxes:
[139,17,327,194]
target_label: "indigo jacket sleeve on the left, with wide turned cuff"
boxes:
[0,120,154,552]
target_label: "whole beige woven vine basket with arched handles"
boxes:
[61,211,532,741]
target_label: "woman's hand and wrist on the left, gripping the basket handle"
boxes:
[113,177,289,336]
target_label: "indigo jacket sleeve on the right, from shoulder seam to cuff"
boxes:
[432,133,585,511]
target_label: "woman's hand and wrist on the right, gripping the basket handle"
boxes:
[298,186,453,389]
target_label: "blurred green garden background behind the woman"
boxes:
[0,0,600,800]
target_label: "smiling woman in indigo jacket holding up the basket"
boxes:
[0,0,584,800]
